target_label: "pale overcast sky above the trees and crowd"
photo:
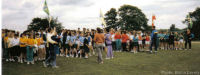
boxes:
[2,0,200,32]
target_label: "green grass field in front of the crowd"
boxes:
[2,43,200,75]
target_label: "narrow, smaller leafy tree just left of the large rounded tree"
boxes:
[105,8,117,29]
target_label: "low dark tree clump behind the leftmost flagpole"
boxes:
[27,17,63,32]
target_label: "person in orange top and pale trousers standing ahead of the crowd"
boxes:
[94,28,105,64]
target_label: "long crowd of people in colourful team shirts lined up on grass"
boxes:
[2,26,194,68]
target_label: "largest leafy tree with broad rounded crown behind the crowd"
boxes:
[117,5,148,30]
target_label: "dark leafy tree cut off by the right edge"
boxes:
[183,7,200,39]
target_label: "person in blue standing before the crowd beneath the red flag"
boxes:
[150,26,158,53]
